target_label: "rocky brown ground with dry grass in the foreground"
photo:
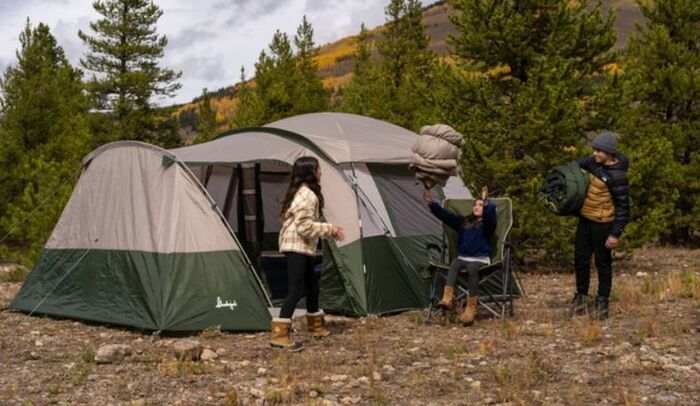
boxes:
[0,249,700,406]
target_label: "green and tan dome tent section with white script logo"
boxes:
[11,141,270,331]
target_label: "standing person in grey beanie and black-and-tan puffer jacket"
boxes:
[571,131,630,320]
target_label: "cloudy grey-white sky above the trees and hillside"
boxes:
[0,0,432,104]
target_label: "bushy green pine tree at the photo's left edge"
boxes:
[0,22,91,263]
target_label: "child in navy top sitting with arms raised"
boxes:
[423,189,497,325]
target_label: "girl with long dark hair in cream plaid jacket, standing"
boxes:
[270,157,343,350]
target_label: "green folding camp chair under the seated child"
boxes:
[426,198,523,322]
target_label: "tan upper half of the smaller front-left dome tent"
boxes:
[46,141,238,253]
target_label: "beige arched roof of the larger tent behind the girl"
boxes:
[171,113,417,164]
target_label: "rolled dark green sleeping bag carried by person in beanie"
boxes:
[540,162,590,216]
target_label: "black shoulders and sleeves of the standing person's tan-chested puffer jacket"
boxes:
[578,154,630,238]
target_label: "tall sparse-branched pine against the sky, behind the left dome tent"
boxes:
[78,0,181,143]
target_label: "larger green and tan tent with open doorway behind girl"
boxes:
[171,113,470,315]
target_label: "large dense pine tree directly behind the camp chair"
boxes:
[441,0,615,261]
